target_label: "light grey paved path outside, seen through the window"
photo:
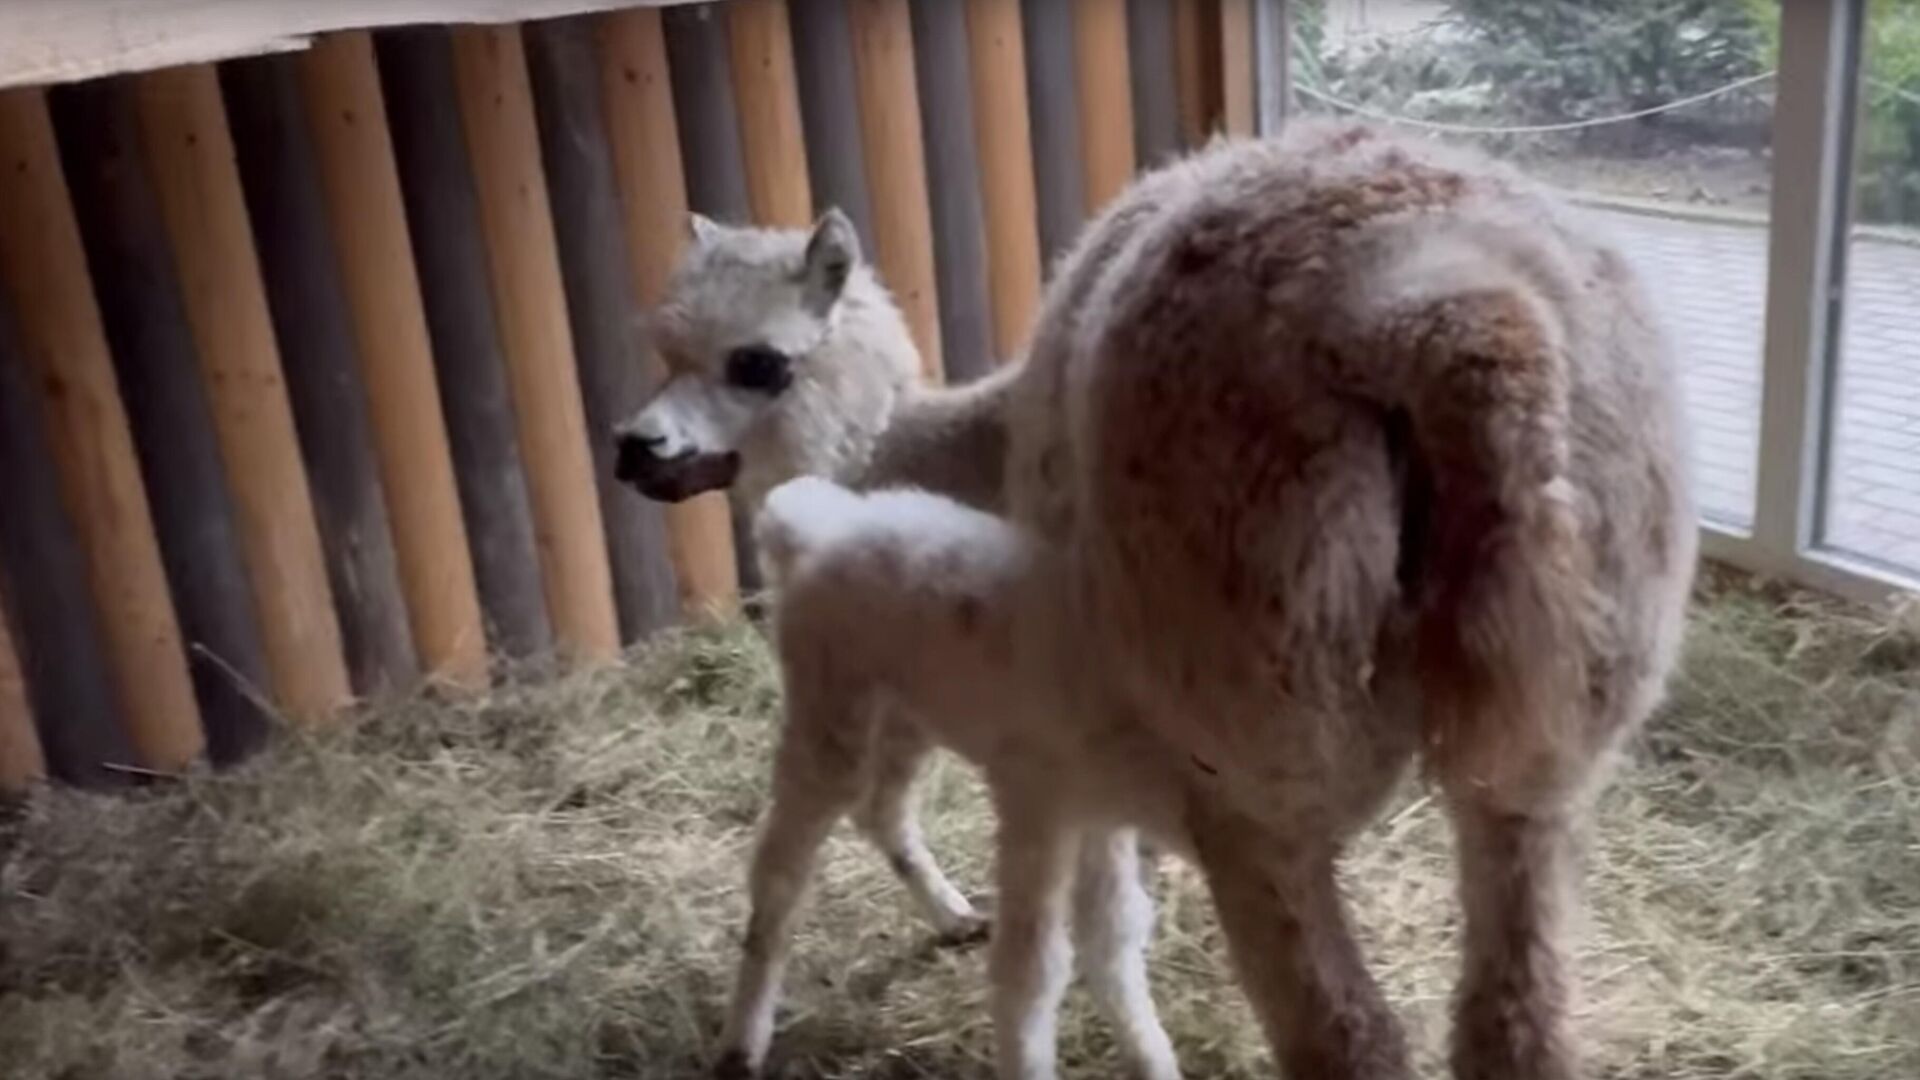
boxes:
[1596,209,1920,573]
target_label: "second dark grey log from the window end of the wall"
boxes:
[1021,0,1087,261]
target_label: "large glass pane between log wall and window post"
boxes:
[1296,0,1780,528]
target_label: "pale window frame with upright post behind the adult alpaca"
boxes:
[1254,0,1920,603]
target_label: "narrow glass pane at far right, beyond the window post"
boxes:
[1822,0,1920,573]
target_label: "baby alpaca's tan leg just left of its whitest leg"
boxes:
[987,780,1075,1080]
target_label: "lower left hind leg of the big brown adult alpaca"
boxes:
[1194,830,1411,1080]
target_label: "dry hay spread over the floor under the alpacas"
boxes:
[0,568,1920,1080]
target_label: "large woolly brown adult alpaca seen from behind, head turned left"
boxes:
[622,123,1695,1080]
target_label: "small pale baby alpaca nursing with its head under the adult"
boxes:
[718,479,1183,1080]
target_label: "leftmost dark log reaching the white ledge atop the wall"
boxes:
[48,79,271,765]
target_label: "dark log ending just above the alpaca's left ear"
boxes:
[660,4,753,220]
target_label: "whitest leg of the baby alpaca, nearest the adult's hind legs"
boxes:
[1073,828,1181,1080]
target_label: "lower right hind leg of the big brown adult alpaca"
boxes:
[1452,799,1580,1080]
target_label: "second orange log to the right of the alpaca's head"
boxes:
[966,0,1041,363]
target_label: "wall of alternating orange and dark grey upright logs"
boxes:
[0,0,1254,792]
